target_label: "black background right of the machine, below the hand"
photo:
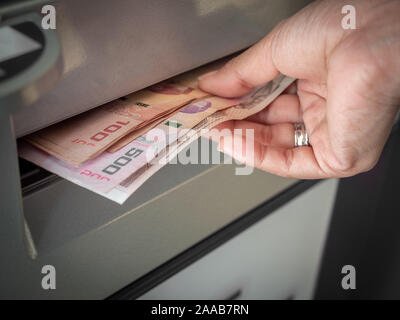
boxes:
[315,123,400,299]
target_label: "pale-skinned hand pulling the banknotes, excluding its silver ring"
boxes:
[199,0,400,179]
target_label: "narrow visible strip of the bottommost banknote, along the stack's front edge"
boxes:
[100,75,295,204]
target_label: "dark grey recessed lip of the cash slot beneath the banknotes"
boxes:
[17,62,223,256]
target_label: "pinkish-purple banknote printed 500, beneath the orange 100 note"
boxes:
[19,96,239,193]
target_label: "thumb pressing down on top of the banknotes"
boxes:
[199,2,341,97]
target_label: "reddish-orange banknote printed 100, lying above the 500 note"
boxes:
[25,79,206,166]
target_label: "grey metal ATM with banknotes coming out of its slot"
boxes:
[0,0,344,299]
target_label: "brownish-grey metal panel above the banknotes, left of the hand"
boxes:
[15,0,308,137]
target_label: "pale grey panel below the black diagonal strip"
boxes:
[140,179,340,300]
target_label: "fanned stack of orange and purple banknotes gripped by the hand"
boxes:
[18,63,294,204]
